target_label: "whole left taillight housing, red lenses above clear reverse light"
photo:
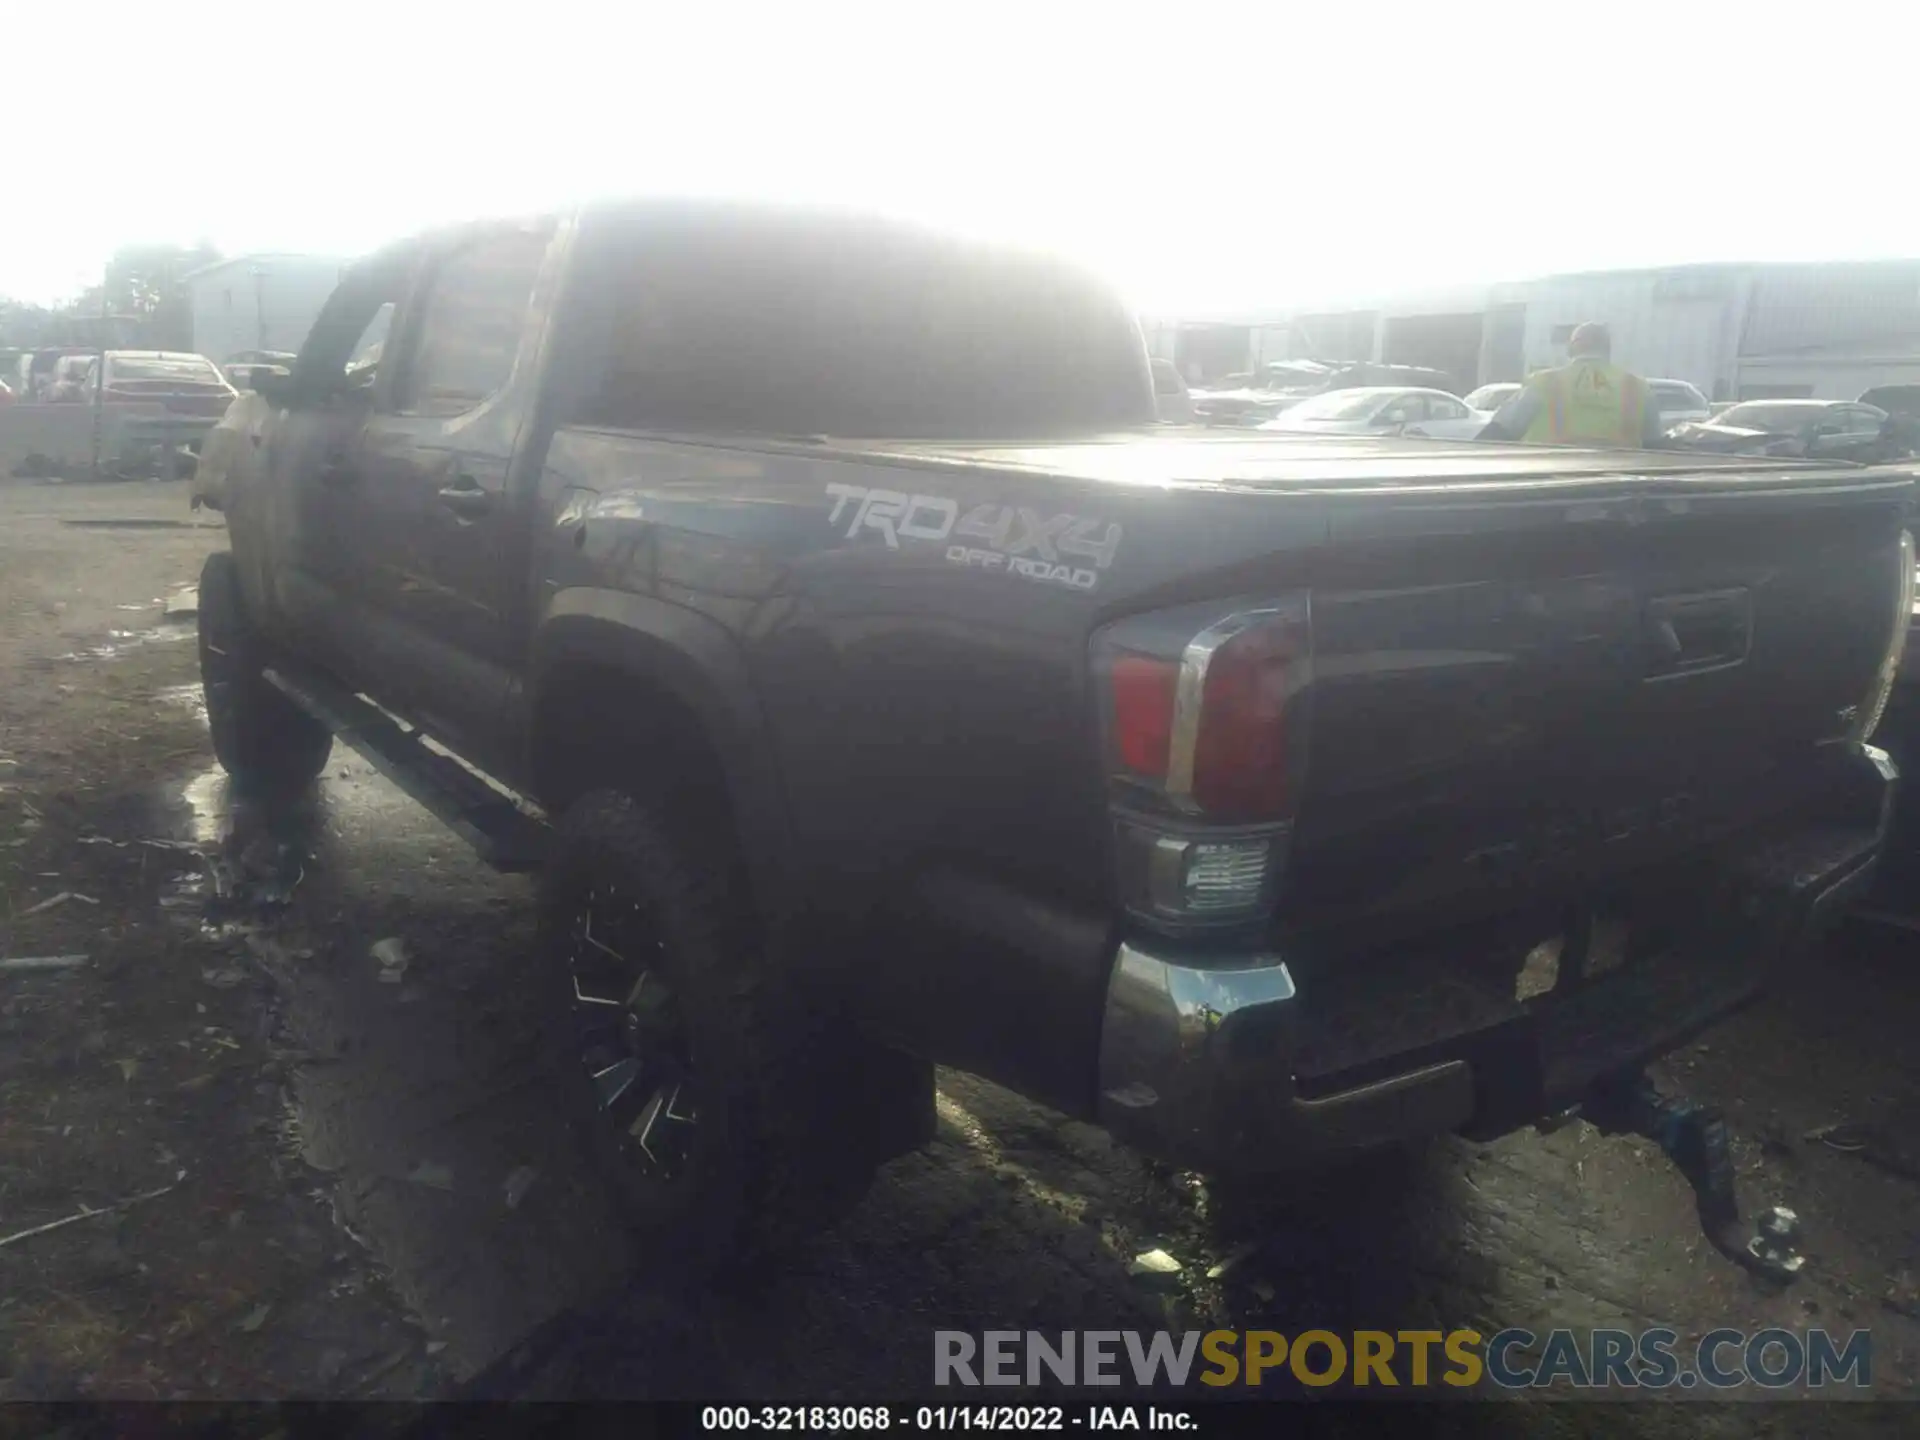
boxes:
[1094,595,1311,931]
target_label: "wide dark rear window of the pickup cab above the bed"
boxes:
[574,213,1156,440]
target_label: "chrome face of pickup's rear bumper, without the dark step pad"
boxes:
[1098,745,1897,1171]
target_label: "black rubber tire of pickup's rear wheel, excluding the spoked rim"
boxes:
[534,789,890,1279]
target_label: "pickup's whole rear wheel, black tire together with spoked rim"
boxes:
[534,791,902,1277]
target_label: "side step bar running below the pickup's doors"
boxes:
[261,670,551,872]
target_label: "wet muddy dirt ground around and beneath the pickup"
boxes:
[0,484,1920,1434]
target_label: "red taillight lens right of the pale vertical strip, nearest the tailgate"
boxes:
[1192,624,1298,820]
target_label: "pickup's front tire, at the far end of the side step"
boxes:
[200,551,334,795]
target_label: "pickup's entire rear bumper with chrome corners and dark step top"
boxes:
[1098,745,1897,1169]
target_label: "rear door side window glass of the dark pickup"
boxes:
[396,228,549,415]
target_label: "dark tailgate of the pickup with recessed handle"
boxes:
[1283,470,1908,931]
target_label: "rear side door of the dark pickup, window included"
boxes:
[324,219,557,751]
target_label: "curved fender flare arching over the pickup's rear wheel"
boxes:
[526,586,793,924]
